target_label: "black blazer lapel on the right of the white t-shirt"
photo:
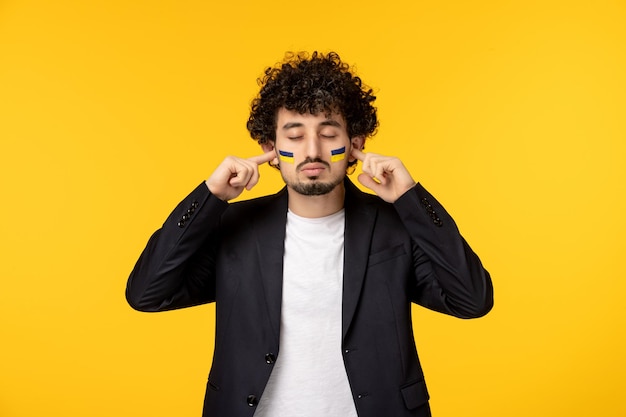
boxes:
[342,179,376,340]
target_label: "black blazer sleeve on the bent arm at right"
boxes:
[394,184,493,318]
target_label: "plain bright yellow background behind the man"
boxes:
[0,0,626,417]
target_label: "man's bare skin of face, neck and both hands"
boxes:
[206,108,415,218]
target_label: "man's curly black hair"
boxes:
[246,51,378,144]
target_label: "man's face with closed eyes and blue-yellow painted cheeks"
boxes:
[270,108,362,195]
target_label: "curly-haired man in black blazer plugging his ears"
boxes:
[126,53,493,417]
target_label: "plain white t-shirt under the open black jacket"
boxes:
[254,210,357,417]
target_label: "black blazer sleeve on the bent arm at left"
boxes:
[126,182,228,312]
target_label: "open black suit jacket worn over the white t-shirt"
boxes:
[126,180,493,417]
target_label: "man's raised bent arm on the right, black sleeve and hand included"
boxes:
[352,149,493,318]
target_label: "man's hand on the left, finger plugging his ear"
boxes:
[205,149,276,201]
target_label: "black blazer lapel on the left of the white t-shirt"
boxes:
[254,188,288,344]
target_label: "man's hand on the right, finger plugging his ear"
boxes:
[350,148,415,203]
